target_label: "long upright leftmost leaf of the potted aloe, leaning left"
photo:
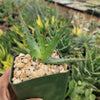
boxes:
[19,12,41,58]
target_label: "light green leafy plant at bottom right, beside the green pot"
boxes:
[66,80,96,100]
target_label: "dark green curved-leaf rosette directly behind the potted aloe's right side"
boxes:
[56,30,75,57]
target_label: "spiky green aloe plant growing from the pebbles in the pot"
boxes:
[19,12,82,64]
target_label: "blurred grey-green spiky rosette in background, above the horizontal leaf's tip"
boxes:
[73,34,96,56]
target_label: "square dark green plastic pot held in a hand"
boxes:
[9,57,69,100]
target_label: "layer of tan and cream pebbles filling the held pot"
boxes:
[12,50,67,84]
